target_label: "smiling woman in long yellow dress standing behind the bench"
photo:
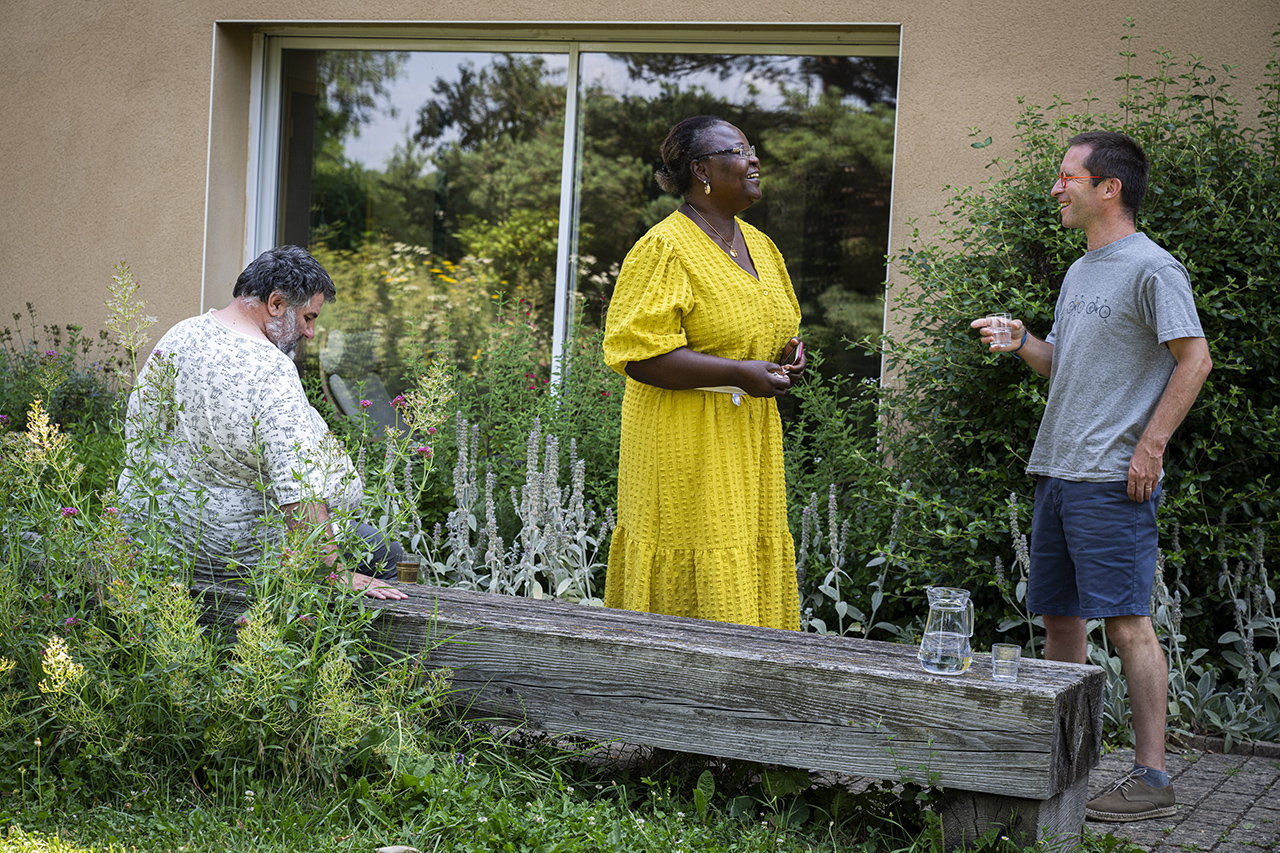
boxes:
[604,115,805,630]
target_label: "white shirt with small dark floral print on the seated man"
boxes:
[118,314,364,578]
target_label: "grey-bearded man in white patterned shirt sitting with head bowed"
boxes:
[118,246,406,598]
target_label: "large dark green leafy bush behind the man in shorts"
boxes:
[788,22,1280,736]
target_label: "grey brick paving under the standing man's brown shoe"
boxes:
[1084,738,1280,853]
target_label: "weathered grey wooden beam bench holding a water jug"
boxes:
[197,585,1106,850]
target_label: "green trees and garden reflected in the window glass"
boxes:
[300,50,896,392]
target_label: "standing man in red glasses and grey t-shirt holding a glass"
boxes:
[972,131,1212,821]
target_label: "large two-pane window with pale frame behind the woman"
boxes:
[264,32,897,392]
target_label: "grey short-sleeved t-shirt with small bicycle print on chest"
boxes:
[1027,233,1204,483]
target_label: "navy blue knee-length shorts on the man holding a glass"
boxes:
[1027,476,1161,619]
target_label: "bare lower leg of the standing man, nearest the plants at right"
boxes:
[1106,607,1169,770]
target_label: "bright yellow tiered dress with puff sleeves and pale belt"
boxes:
[604,211,800,630]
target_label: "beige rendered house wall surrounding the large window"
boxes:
[0,0,1280,345]
